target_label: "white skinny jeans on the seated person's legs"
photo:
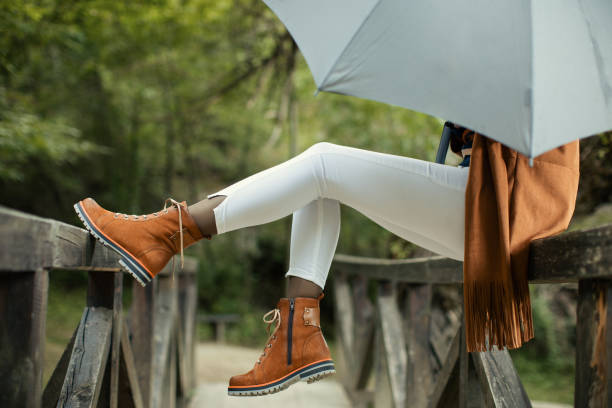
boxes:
[208,142,469,288]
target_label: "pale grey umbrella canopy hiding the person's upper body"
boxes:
[264,0,612,157]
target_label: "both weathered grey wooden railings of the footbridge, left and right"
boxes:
[0,207,612,408]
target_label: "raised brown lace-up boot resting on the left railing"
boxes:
[74,198,211,286]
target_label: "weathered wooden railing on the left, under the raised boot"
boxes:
[0,207,197,408]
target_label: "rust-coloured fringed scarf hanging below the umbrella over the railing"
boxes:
[463,134,579,351]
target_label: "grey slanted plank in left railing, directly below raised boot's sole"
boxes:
[58,306,113,407]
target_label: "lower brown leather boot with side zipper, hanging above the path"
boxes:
[227,294,336,396]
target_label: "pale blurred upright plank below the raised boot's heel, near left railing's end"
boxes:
[149,276,177,408]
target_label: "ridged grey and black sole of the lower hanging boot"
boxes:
[227,360,336,397]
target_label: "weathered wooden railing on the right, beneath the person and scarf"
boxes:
[330,225,612,408]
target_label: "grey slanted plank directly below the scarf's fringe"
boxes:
[471,350,531,408]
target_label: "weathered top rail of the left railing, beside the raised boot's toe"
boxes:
[0,206,118,272]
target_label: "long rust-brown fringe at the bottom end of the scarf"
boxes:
[463,279,533,352]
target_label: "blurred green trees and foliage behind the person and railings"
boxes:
[0,0,612,402]
